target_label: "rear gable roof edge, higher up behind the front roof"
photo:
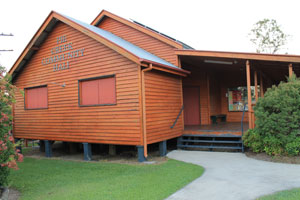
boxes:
[91,10,191,49]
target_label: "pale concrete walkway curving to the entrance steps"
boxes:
[167,150,300,200]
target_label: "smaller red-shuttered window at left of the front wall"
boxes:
[25,86,48,109]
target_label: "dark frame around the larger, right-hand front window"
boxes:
[78,74,117,107]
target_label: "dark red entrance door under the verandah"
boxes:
[183,86,200,125]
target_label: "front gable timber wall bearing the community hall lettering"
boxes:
[14,23,141,145]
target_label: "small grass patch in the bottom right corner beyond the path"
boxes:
[258,188,300,200]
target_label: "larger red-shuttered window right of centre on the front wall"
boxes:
[79,76,116,106]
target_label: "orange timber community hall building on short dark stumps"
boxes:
[9,11,300,161]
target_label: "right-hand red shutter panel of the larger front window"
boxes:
[99,77,116,104]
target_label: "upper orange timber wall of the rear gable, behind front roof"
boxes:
[98,17,177,65]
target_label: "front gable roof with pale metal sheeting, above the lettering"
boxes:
[9,11,189,78]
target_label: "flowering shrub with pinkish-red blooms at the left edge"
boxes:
[0,66,23,186]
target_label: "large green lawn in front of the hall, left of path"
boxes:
[11,158,204,200]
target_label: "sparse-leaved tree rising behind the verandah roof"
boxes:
[249,19,289,54]
